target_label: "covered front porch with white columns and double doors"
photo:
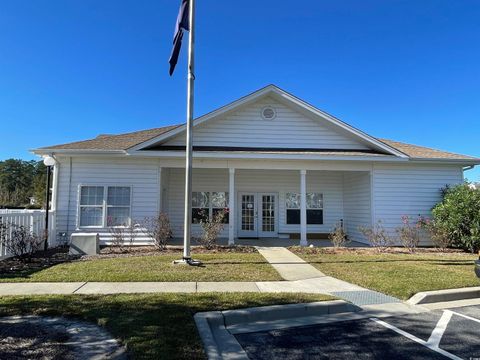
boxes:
[160,165,373,246]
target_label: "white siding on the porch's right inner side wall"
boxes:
[343,171,372,243]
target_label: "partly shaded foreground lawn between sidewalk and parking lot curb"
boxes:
[0,293,331,359]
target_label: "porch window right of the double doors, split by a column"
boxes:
[285,193,323,225]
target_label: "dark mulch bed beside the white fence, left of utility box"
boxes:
[0,247,78,276]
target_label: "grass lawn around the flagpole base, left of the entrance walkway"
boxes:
[0,252,282,282]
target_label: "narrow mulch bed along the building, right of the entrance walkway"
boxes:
[289,246,472,256]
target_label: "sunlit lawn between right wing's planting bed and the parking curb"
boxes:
[290,247,480,299]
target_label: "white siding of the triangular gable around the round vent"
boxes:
[164,98,368,149]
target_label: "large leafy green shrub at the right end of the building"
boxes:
[432,184,480,252]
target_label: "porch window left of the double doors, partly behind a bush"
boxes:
[192,191,228,224]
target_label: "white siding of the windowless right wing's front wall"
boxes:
[373,164,463,245]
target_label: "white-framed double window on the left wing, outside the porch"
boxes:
[78,185,131,228]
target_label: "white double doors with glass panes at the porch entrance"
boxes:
[237,192,278,238]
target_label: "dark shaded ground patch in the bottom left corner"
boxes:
[0,322,74,360]
